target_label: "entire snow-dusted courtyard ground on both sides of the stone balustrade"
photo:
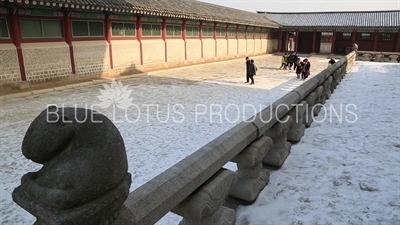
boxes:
[0,56,400,225]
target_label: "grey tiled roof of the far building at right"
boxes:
[258,10,400,28]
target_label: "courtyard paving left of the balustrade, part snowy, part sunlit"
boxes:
[0,55,336,224]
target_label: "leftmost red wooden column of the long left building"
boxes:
[10,10,26,81]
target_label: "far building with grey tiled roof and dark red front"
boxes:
[258,10,400,54]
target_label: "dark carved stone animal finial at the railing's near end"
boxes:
[13,107,131,225]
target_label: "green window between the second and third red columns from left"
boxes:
[72,21,104,37]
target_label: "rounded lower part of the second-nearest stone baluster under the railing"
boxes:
[229,169,270,202]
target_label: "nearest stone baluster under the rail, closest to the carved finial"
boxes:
[172,169,236,225]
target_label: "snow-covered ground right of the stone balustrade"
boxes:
[237,62,400,225]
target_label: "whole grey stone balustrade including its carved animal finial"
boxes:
[13,52,360,225]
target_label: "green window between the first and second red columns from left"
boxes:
[20,19,63,38]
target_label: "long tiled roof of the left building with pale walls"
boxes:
[0,0,279,28]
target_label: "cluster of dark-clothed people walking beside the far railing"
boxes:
[279,52,311,80]
